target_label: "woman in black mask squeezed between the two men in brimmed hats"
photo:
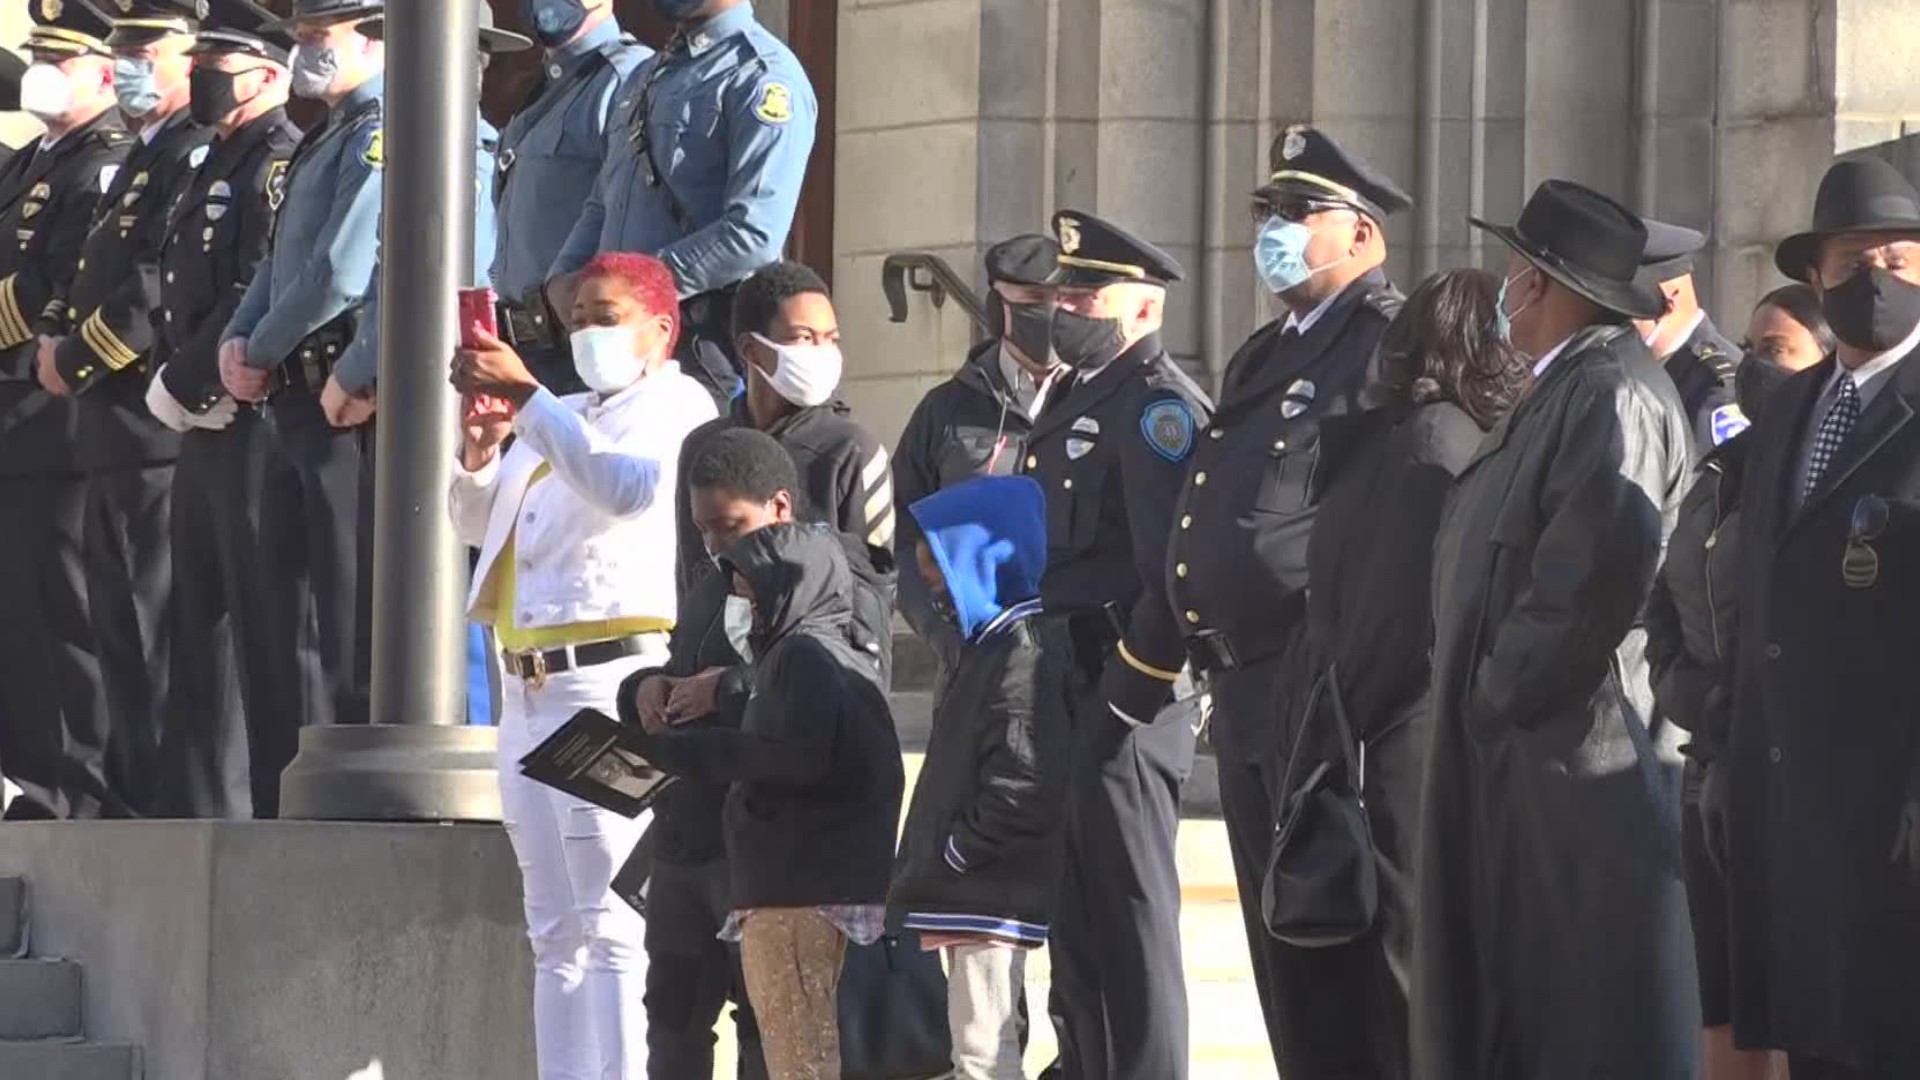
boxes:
[1647,282,1834,1080]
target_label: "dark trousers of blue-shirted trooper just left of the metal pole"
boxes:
[253,390,372,776]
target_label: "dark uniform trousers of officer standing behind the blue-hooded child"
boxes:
[1048,648,1194,1080]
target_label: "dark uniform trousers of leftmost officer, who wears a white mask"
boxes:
[0,473,117,819]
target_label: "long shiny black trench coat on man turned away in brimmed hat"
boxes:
[1409,327,1699,1080]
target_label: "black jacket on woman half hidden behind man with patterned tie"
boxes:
[1647,428,1747,761]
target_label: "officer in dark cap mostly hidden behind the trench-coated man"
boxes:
[1634,217,1747,454]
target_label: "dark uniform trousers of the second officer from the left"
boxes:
[83,455,173,817]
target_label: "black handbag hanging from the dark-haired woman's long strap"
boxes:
[1260,665,1380,949]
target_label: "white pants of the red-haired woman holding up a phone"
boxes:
[495,634,666,1080]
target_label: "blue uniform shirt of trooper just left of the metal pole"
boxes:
[221,75,386,369]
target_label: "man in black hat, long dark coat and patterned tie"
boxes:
[1703,161,1920,1080]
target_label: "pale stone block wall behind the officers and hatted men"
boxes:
[835,0,1920,438]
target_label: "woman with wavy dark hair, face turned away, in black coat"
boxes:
[1275,269,1528,1080]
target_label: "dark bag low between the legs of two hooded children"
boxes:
[839,930,954,1080]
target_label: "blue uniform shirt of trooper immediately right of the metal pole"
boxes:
[488,19,653,302]
